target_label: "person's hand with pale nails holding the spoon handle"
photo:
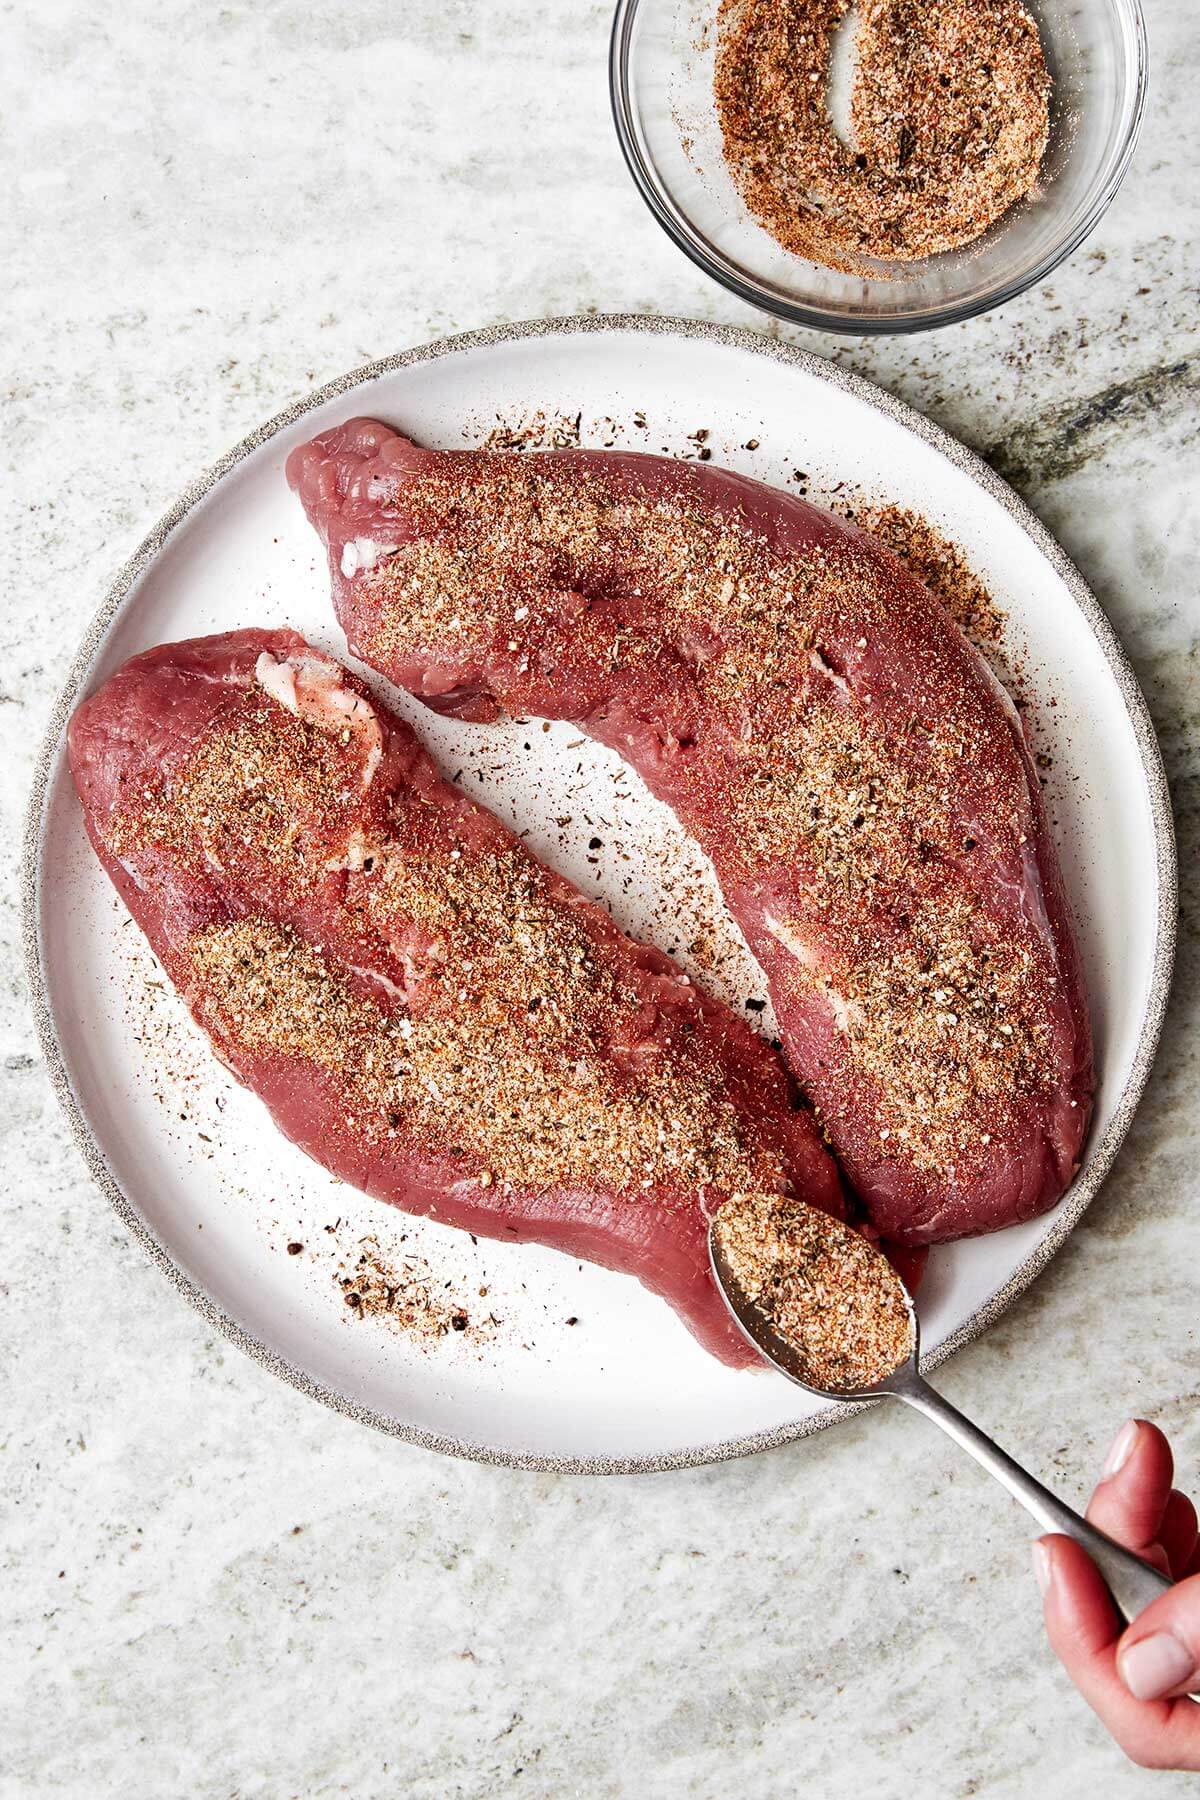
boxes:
[1033,1418,1200,1769]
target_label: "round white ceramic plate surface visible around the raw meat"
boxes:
[27,319,1175,1471]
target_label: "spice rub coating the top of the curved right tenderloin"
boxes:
[363,457,1056,1172]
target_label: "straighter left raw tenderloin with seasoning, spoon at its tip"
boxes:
[70,630,844,1364]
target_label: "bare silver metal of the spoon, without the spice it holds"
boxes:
[709,1222,1171,1625]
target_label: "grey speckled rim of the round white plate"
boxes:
[22,313,1178,1474]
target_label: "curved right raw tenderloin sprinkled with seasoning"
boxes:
[288,419,1094,1244]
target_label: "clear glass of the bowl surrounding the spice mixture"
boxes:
[610,0,1146,333]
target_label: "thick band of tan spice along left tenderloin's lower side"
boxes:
[189,900,772,1195]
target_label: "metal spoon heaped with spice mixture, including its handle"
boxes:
[709,1193,1171,1622]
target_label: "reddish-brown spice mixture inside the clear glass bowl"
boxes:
[714,0,1051,274]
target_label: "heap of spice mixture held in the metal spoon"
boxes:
[712,1193,912,1393]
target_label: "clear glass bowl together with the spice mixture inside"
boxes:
[610,0,1146,333]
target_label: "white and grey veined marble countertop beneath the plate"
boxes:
[0,0,1200,1800]
